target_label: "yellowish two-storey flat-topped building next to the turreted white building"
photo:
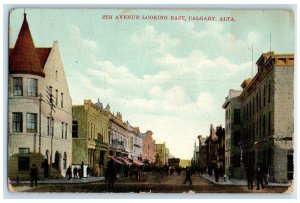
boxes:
[72,100,110,176]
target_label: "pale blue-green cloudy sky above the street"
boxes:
[9,9,295,159]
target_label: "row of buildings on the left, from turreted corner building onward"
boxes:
[8,14,170,179]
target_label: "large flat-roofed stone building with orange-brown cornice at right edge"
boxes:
[240,52,294,182]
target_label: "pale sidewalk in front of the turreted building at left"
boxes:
[11,177,104,185]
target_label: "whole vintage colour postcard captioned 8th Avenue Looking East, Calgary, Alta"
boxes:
[7,8,295,195]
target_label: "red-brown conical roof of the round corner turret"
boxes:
[9,14,45,77]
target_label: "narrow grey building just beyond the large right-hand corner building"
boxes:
[222,89,245,179]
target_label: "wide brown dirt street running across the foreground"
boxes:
[13,173,288,193]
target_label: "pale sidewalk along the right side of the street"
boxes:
[201,174,291,187]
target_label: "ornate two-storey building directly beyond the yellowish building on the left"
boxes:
[109,112,130,158]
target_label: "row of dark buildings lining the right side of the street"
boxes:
[194,52,294,182]
